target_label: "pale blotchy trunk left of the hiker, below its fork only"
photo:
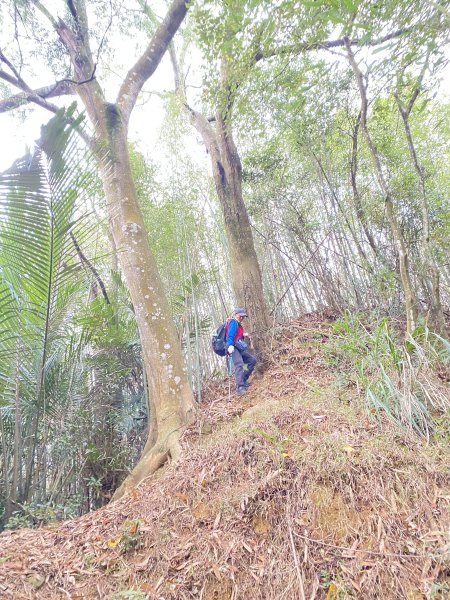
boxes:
[92,112,194,498]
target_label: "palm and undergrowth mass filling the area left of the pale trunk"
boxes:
[0,111,146,526]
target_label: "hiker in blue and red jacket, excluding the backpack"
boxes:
[225,308,256,396]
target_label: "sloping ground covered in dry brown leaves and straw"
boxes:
[0,315,450,600]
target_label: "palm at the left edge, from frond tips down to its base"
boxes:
[0,107,99,519]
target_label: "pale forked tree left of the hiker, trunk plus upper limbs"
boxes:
[50,0,195,499]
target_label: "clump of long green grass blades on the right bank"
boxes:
[327,312,450,438]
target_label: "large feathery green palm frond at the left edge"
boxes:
[0,107,99,410]
